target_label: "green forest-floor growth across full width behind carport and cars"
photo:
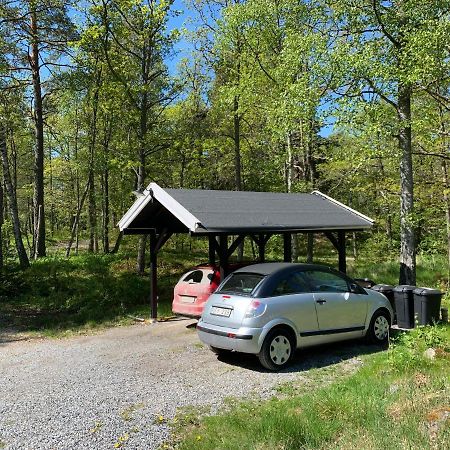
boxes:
[0,236,449,336]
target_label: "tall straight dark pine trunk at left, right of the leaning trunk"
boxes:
[29,10,46,258]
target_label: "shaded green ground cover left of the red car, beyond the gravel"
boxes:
[0,246,204,336]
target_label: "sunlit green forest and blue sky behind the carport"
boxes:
[0,0,450,330]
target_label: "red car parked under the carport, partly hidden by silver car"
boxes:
[172,263,248,318]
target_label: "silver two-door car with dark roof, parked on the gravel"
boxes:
[197,263,394,370]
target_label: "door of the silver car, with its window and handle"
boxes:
[306,270,367,333]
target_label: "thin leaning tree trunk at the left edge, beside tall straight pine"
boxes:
[0,124,30,269]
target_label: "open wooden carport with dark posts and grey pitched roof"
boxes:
[118,183,374,319]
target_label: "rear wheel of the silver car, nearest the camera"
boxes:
[258,329,294,370]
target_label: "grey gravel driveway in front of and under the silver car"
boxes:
[0,320,368,450]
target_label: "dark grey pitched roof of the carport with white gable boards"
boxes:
[119,183,374,235]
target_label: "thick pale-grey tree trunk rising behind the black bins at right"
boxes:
[398,84,416,285]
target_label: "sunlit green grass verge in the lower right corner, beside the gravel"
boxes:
[169,326,450,450]
